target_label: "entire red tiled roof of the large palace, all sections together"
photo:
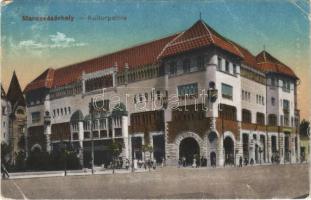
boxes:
[25,20,297,92]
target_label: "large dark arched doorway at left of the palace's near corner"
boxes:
[179,137,200,165]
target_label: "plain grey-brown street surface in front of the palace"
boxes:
[1,164,309,199]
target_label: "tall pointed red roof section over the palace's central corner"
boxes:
[159,20,243,58]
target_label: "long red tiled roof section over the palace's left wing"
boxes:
[25,34,176,92]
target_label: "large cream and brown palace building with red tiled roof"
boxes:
[24,20,300,166]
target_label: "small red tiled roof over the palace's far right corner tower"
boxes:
[256,51,298,79]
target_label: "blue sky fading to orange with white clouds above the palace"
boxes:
[1,0,311,119]
